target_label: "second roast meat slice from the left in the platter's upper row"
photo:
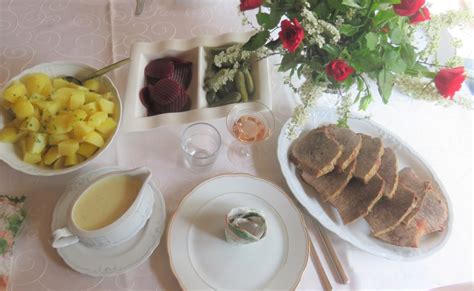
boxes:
[328,124,362,171]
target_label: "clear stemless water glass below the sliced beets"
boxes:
[181,122,221,168]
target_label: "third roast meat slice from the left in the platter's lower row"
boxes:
[365,185,416,236]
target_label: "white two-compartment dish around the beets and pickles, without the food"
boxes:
[123,32,272,132]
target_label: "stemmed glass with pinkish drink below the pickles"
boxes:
[226,102,275,166]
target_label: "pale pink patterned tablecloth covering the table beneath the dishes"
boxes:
[0,0,473,290]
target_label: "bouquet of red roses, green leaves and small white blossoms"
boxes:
[206,0,472,136]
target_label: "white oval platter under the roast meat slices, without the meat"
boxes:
[278,107,453,260]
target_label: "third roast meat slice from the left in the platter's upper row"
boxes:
[354,133,384,184]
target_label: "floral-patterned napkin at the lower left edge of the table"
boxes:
[0,195,26,291]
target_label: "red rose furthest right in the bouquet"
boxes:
[434,67,466,99]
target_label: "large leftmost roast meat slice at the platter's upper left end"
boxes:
[290,128,342,177]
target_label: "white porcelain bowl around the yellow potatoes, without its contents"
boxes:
[0,62,122,176]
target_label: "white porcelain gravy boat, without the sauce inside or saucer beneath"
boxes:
[52,167,155,248]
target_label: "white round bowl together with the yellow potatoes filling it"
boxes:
[0,62,122,176]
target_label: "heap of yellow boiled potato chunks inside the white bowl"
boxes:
[0,73,117,169]
